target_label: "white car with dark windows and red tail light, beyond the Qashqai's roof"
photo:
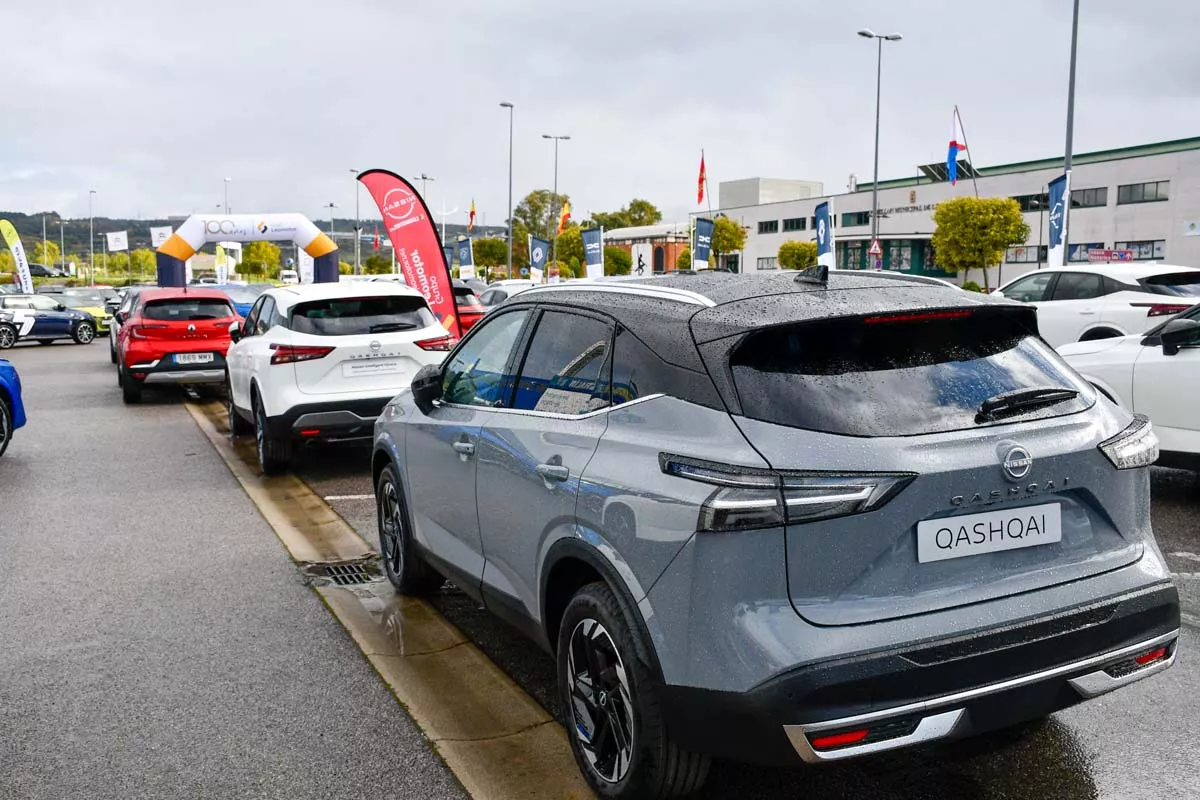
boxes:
[994,263,1200,347]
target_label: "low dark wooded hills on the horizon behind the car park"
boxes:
[0,211,505,257]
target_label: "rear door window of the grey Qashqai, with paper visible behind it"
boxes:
[512,311,612,415]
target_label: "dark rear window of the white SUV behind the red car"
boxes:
[288,295,438,336]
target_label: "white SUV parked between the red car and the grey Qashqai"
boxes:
[226,282,452,474]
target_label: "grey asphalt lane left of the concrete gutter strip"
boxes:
[0,341,466,800]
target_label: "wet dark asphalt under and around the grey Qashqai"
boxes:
[296,422,1200,800]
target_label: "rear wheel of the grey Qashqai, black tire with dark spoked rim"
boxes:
[557,583,710,800]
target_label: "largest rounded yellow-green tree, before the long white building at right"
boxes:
[932,197,1030,288]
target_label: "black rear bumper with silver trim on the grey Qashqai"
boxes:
[661,585,1180,765]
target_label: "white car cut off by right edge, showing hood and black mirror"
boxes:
[1058,305,1200,469]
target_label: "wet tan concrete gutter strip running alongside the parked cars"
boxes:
[187,403,594,800]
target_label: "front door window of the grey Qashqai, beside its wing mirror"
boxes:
[442,309,529,407]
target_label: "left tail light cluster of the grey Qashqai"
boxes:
[659,453,916,531]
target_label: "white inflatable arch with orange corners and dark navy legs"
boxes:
[156,213,337,287]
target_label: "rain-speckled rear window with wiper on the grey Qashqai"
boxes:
[730,309,1093,437]
